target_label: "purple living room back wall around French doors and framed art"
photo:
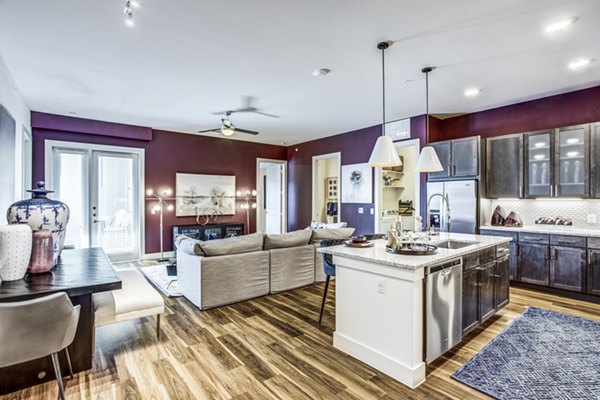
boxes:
[32,117,286,253]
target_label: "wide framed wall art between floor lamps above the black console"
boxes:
[175,173,235,217]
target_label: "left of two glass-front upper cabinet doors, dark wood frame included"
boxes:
[524,131,554,197]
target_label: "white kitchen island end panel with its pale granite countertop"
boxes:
[319,233,510,388]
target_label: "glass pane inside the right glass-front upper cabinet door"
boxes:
[558,128,585,196]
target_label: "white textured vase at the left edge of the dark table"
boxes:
[0,225,32,281]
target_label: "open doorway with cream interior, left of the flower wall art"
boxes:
[311,152,342,224]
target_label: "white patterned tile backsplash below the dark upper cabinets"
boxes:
[481,199,600,229]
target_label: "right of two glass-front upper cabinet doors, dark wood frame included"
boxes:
[554,125,590,197]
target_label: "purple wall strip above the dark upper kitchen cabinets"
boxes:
[432,86,600,141]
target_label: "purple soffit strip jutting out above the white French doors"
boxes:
[31,111,152,141]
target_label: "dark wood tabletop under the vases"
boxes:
[0,247,121,302]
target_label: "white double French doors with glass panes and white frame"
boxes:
[45,141,144,262]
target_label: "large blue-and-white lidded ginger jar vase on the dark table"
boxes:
[6,181,70,265]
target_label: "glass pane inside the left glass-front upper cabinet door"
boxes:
[527,133,552,196]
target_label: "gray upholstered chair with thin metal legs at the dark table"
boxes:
[0,292,80,400]
